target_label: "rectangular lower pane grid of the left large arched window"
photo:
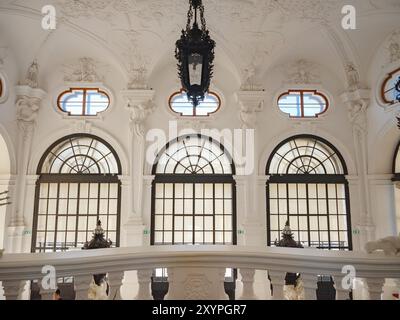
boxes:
[32,182,119,252]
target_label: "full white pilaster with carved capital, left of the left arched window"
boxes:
[8,85,46,252]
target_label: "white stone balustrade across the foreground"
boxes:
[0,246,400,300]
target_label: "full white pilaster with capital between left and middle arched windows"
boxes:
[121,89,155,245]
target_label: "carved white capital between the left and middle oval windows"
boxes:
[121,89,156,137]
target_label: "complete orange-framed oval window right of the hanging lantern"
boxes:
[278,90,329,118]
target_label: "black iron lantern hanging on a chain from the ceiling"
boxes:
[175,0,215,107]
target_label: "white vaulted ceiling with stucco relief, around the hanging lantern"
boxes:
[0,0,400,88]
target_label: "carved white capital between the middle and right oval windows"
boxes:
[235,90,266,129]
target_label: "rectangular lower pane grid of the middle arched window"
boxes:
[153,183,234,245]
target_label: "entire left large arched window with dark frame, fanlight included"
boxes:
[32,134,121,252]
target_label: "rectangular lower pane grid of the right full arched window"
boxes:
[267,183,350,250]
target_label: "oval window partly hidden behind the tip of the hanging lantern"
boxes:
[169,91,221,117]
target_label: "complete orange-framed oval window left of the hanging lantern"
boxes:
[57,88,110,116]
